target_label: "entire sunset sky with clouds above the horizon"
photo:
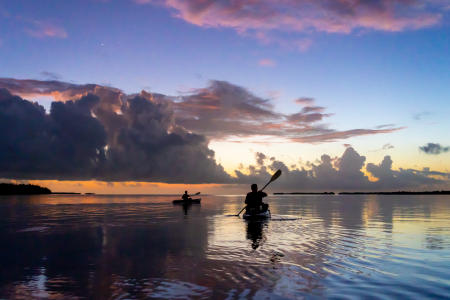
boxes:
[0,0,450,193]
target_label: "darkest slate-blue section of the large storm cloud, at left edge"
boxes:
[0,89,106,179]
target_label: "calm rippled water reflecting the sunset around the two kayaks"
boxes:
[0,195,450,299]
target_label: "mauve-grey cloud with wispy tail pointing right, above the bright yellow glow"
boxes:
[174,81,402,143]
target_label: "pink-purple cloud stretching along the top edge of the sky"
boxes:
[138,0,448,51]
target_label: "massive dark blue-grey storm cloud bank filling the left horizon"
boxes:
[0,89,230,183]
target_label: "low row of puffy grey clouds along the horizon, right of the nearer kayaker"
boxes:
[236,147,450,191]
